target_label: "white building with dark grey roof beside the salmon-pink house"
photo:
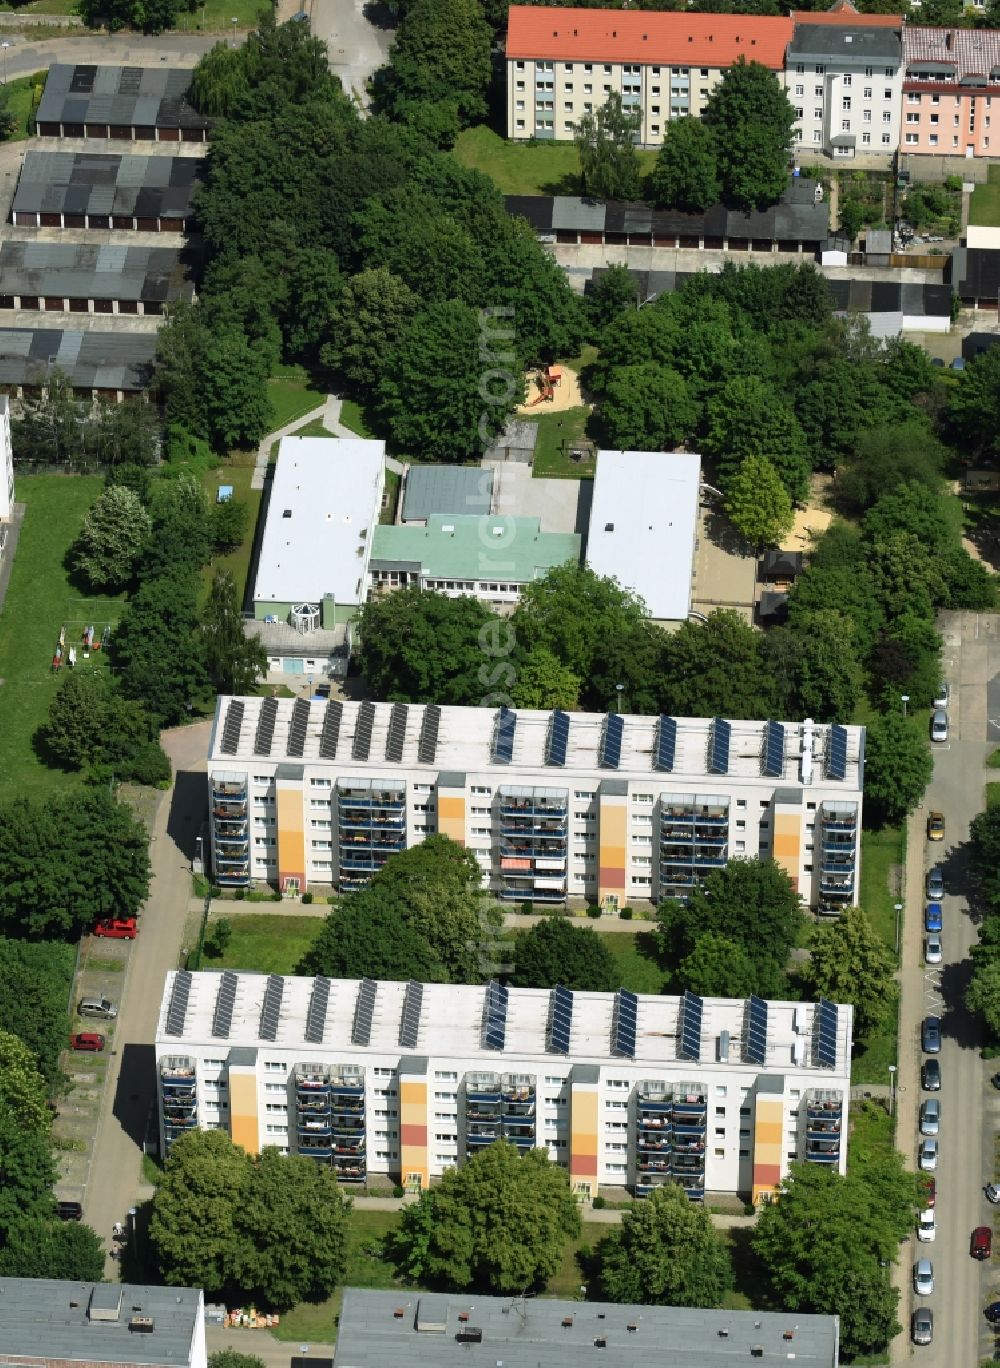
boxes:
[784,23,903,160]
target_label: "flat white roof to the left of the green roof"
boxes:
[253,436,386,603]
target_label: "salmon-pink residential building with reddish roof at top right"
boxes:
[900,25,1000,157]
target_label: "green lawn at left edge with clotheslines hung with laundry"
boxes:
[0,475,122,798]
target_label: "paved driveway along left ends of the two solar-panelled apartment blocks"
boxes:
[83,722,211,1278]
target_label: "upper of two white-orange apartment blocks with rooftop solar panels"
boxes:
[208,700,865,912]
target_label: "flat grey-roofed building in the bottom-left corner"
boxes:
[0,1278,202,1368]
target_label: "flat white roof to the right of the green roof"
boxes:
[587,451,702,621]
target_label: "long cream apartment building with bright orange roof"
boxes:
[506,4,792,146]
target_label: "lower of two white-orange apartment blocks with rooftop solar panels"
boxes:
[156,970,852,1201]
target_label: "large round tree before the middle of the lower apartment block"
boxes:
[394,1140,580,1295]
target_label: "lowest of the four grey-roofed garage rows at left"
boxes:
[0,328,156,390]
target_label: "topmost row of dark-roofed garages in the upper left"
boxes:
[36,63,208,129]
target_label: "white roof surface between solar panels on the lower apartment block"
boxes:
[156,970,852,1086]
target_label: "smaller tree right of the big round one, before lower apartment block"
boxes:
[596,1183,732,1306]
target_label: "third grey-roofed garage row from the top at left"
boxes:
[0,241,194,304]
